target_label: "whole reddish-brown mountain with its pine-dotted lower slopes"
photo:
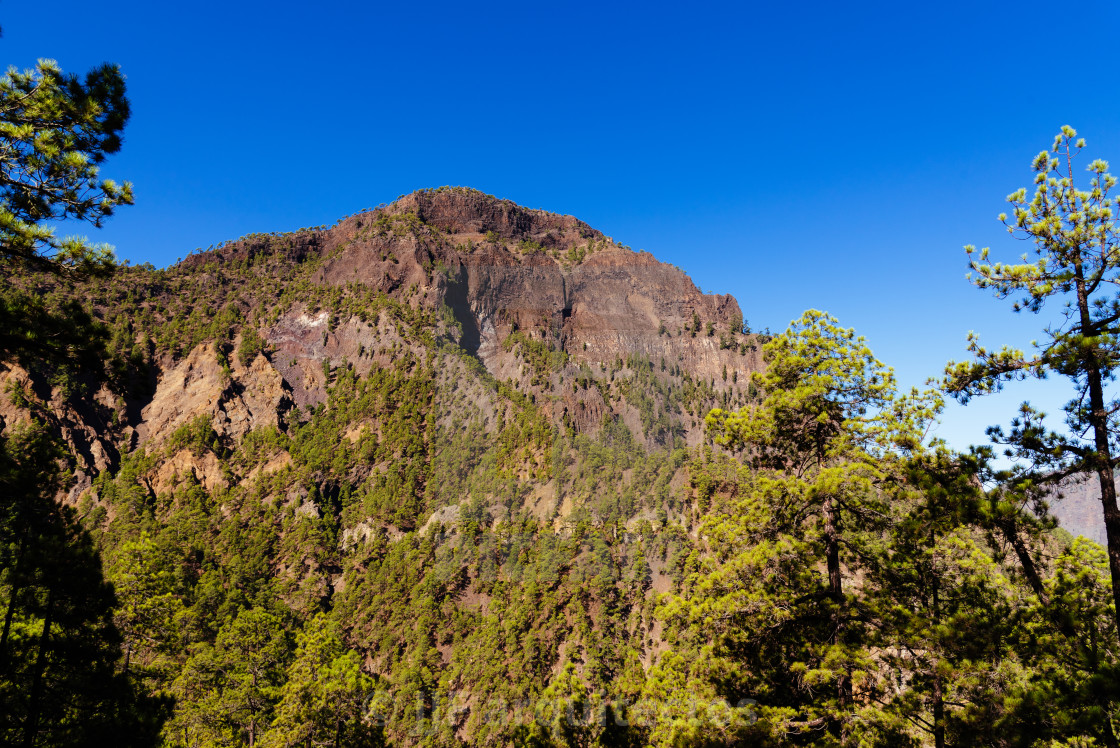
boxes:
[0,188,763,745]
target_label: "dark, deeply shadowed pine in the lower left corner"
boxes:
[0,418,158,746]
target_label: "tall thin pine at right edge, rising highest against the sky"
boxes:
[944,127,1120,649]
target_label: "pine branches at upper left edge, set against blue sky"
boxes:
[0,44,132,396]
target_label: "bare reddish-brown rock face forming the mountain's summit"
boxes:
[309,189,760,389]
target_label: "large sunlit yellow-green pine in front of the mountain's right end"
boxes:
[685,310,939,741]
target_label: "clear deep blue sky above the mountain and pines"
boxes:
[0,0,1120,446]
